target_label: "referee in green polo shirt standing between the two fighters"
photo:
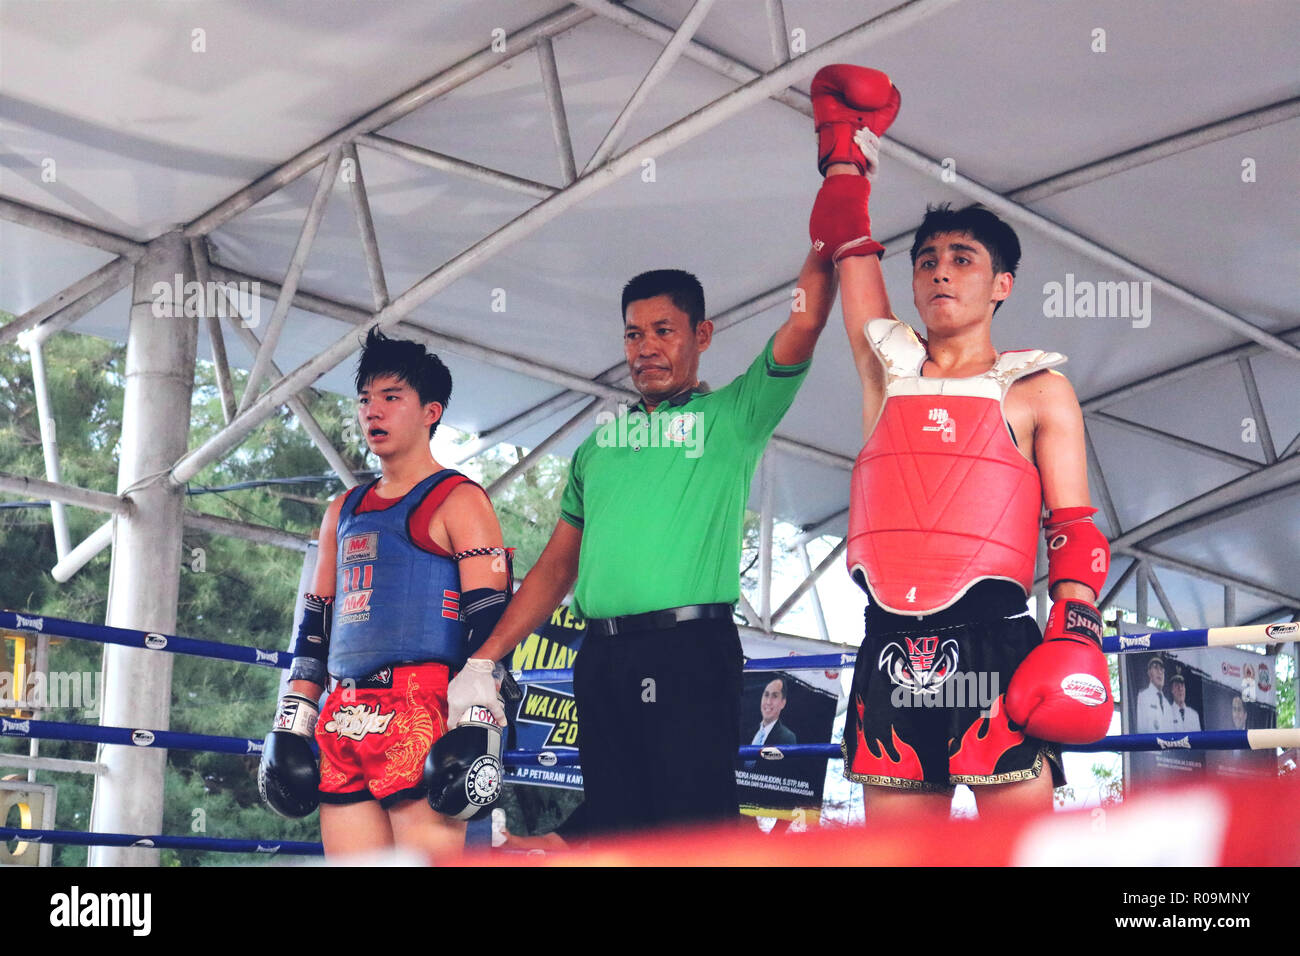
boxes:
[449,254,836,832]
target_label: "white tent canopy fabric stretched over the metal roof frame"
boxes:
[0,0,1300,627]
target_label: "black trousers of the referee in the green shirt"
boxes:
[573,620,744,835]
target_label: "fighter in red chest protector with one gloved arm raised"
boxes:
[810,65,1114,816]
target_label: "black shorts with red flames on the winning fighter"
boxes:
[842,581,1065,792]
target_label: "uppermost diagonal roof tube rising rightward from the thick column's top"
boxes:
[183,7,592,237]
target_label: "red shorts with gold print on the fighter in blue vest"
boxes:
[316,663,449,809]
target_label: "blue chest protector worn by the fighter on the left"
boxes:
[329,468,467,678]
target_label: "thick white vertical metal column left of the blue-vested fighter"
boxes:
[90,232,199,866]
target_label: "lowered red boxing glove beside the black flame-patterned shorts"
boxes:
[1006,598,1115,744]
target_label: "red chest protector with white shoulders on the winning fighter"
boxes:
[848,319,1065,615]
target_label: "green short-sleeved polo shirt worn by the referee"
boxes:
[560,339,811,618]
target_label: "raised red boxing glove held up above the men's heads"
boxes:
[810,64,901,176]
